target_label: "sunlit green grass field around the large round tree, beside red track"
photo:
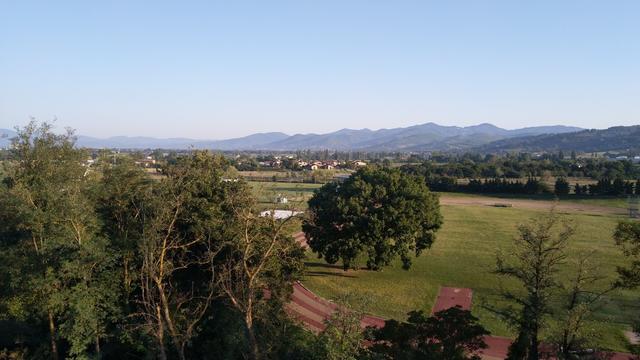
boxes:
[304,206,640,351]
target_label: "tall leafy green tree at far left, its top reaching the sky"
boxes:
[0,122,116,359]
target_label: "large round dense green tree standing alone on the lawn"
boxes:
[302,168,442,270]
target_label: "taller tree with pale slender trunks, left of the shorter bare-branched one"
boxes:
[131,152,246,359]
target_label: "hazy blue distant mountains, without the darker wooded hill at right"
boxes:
[0,123,582,151]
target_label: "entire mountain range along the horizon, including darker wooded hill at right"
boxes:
[0,123,640,152]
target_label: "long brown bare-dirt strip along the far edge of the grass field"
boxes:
[440,194,626,215]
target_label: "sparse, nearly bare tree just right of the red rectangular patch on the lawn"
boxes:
[496,211,575,360]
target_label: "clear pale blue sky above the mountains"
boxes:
[0,0,640,139]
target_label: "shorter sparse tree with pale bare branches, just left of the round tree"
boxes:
[218,208,304,360]
